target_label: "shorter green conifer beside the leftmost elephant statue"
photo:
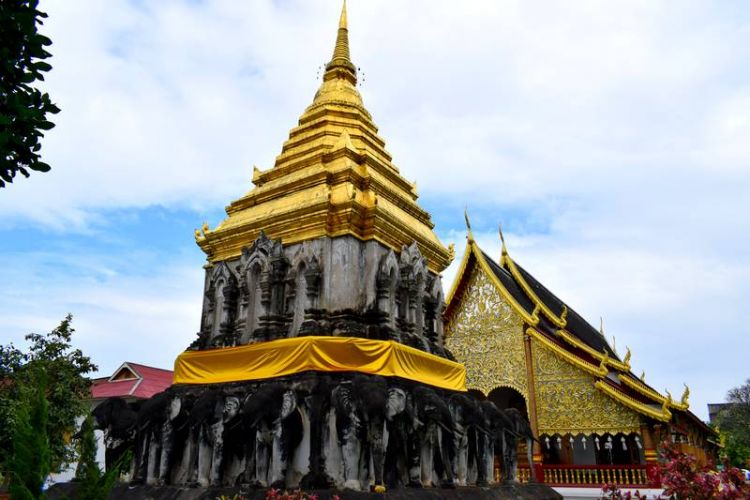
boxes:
[75,415,132,500]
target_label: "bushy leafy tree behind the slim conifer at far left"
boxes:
[0,315,96,472]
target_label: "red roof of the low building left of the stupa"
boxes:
[91,362,172,399]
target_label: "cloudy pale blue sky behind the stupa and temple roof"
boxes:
[0,0,750,418]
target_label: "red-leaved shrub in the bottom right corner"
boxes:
[660,442,750,500]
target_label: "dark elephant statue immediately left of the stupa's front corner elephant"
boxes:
[242,383,302,488]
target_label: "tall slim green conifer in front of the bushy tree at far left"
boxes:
[8,370,50,500]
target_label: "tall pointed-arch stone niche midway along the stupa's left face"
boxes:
[235,231,289,344]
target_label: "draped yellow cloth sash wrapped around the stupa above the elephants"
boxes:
[174,337,466,391]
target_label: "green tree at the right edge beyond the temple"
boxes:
[717,378,750,467]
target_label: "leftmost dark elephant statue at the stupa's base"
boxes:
[92,398,138,470]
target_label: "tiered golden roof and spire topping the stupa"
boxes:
[196,0,451,272]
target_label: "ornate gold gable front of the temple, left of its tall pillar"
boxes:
[445,266,529,402]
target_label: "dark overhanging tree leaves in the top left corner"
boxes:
[0,0,60,188]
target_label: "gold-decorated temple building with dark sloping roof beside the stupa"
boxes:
[444,220,717,487]
